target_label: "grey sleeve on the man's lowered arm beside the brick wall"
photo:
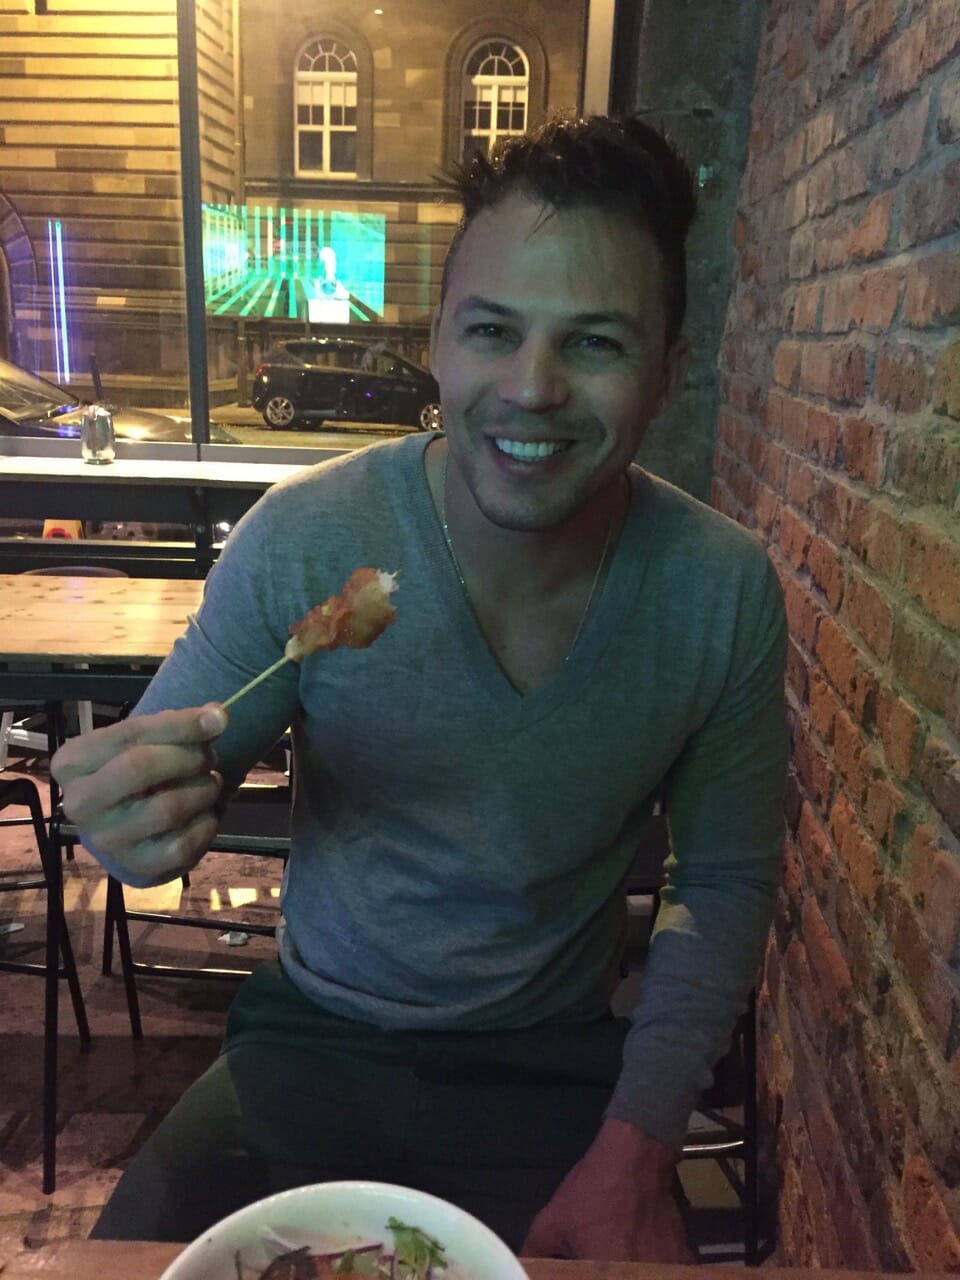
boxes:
[607,550,787,1152]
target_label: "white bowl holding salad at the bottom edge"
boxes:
[160,1181,527,1280]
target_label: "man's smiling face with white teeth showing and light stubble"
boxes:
[430,193,686,530]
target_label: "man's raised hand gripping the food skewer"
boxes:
[50,703,227,888]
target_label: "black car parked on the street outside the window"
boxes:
[252,338,442,431]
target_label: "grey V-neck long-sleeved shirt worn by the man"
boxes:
[138,436,786,1148]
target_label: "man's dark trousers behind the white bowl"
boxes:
[92,964,627,1249]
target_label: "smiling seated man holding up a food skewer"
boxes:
[54,118,786,1261]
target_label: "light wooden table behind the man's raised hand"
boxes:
[0,573,204,703]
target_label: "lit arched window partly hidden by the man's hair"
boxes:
[461,40,530,160]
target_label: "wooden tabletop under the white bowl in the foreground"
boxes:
[0,1240,947,1280]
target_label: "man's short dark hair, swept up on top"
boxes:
[440,115,696,343]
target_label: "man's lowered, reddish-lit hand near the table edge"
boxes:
[521,1120,694,1262]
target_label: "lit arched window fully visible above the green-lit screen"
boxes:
[294,36,357,178]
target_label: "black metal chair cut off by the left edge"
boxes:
[0,778,90,1196]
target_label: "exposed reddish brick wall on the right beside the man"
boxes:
[713,0,960,1271]
